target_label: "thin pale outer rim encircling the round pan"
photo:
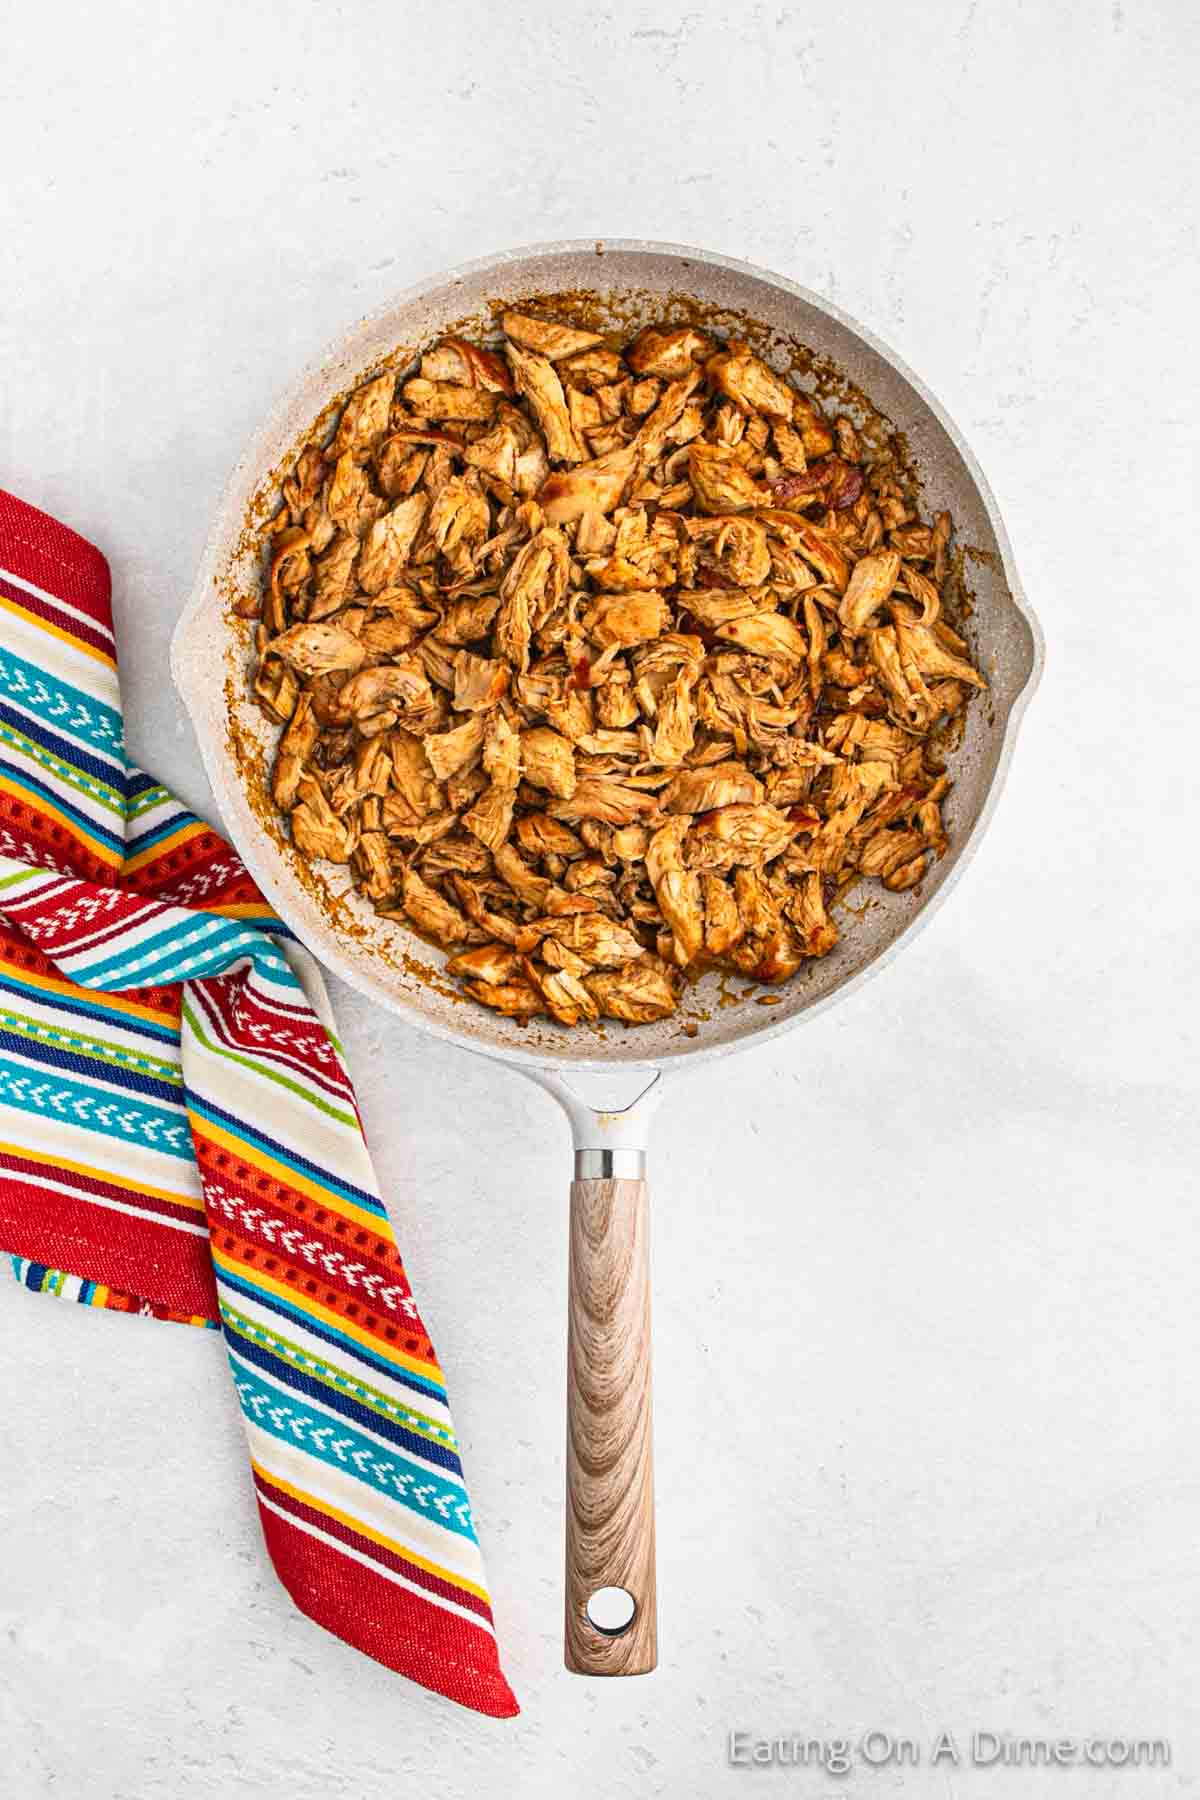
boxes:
[171,238,1045,1073]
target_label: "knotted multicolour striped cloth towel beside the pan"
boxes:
[0,493,516,1717]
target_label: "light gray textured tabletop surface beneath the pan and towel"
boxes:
[0,0,1200,1800]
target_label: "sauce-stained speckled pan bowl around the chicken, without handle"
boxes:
[171,239,1042,1066]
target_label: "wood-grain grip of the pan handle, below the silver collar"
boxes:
[565,1181,658,1676]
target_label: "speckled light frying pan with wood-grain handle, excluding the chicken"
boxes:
[171,239,1042,1676]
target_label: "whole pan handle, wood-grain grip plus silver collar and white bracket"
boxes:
[531,1067,662,1676]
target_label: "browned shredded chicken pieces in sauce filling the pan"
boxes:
[254,311,986,1026]
